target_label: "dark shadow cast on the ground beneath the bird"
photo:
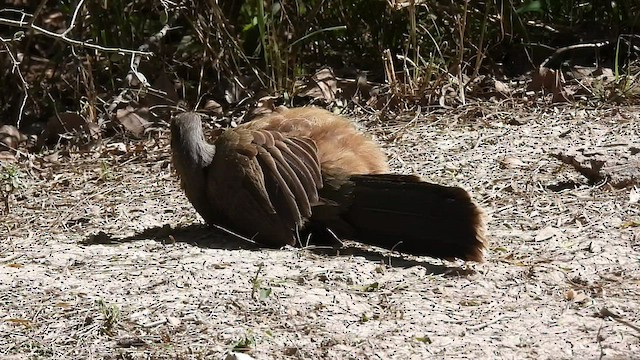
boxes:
[81,224,476,277]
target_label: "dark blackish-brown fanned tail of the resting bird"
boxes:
[318,174,486,261]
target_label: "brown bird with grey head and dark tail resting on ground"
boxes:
[171,107,485,261]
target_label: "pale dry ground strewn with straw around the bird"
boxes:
[0,105,640,359]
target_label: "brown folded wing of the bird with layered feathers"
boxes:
[207,129,322,245]
